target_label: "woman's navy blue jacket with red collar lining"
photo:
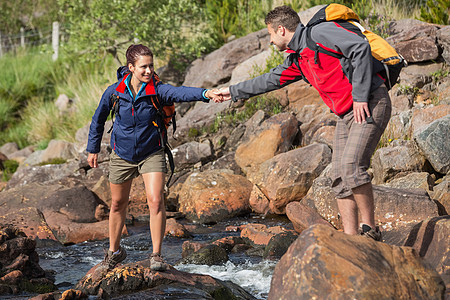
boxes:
[86,67,209,162]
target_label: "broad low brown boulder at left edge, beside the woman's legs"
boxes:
[0,183,114,244]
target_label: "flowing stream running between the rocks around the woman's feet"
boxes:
[27,215,291,299]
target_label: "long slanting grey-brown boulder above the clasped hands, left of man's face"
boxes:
[183,29,269,88]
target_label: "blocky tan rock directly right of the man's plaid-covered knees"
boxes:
[372,140,425,184]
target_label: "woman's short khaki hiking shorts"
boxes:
[109,149,167,184]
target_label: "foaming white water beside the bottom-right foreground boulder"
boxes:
[175,260,276,299]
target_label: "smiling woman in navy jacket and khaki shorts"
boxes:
[86,45,220,271]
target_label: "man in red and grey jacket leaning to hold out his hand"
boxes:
[222,6,391,241]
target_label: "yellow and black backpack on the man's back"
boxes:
[306,3,407,89]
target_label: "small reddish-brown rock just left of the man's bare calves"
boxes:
[286,201,333,233]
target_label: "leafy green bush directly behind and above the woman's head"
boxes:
[58,0,214,68]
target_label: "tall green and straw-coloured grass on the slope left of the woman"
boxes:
[0,49,117,148]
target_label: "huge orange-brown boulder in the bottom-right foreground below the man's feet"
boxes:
[268,225,445,300]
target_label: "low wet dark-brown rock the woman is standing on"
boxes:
[76,259,255,300]
